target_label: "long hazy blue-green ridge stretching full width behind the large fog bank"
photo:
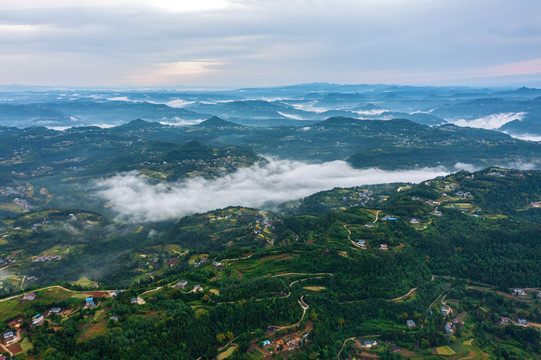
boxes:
[0,117,541,171]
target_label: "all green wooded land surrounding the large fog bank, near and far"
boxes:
[0,118,541,360]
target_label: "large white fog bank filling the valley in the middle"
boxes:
[96,159,449,222]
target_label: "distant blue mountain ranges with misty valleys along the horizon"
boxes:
[0,83,541,136]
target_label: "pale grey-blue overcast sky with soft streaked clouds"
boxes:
[0,0,541,87]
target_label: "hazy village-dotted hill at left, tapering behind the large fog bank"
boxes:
[0,125,261,186]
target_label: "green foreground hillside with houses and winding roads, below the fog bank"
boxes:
[0,167,541,360]
